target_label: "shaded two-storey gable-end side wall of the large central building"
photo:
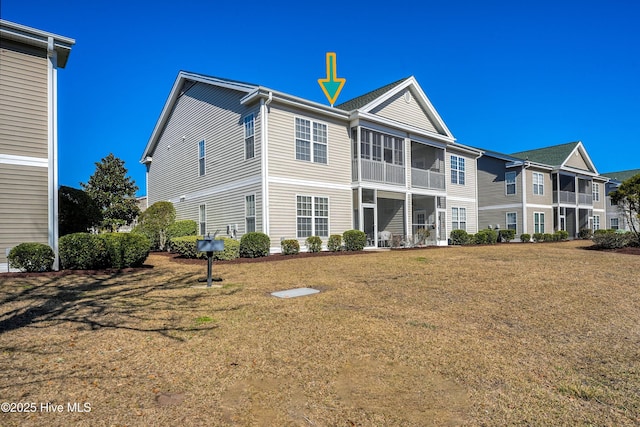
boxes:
[147,83,263,234]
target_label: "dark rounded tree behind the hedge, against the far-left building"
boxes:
[58,185,102,236]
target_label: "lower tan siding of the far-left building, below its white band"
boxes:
[0,164,49,263]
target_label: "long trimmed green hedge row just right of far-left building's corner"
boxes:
[59,233,151,270]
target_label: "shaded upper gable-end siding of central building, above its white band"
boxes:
[148,83,261,207]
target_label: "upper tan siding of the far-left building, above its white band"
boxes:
[0,40,48,158]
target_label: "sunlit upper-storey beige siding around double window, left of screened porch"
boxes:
[268,102,351,185]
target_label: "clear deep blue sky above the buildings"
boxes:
[0,0,640,195]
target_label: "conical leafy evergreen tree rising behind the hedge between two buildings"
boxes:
[80,153,140,231]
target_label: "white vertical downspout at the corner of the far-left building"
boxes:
[47,37,60,270]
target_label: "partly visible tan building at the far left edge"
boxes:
[0,20,75,271]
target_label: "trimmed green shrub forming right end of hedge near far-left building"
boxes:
[98,233,151,268]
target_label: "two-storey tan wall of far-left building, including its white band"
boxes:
[0,39,52,264]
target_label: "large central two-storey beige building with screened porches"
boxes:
[141,72,481,252]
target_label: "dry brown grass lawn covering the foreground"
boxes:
[0,242,640,426]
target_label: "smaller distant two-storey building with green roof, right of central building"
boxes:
[478,142,608,238]
